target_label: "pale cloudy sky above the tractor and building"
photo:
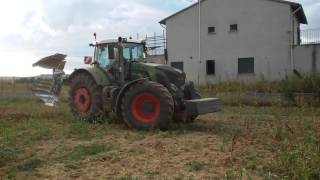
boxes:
[0,0,320,76]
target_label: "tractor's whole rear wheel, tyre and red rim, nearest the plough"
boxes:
[69,73,103,123]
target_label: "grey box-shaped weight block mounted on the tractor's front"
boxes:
[185,98,221,116]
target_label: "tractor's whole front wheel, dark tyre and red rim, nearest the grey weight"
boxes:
[121,81,174,130]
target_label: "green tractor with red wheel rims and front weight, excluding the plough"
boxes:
[33,34,220,130]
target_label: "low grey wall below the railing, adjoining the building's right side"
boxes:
[293,44,320,73]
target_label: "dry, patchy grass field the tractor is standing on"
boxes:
[0,99,320,179]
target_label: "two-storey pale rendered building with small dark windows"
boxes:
[160,0,320,83]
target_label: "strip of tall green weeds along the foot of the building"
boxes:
[200,73,320,106]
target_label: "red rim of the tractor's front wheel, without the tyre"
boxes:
[131,93,160,123]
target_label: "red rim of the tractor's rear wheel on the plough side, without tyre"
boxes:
[73,87,91,113]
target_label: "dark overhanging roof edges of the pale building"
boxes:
[159,0,308,25]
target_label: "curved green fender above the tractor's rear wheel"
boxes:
[69,68,110,86]
